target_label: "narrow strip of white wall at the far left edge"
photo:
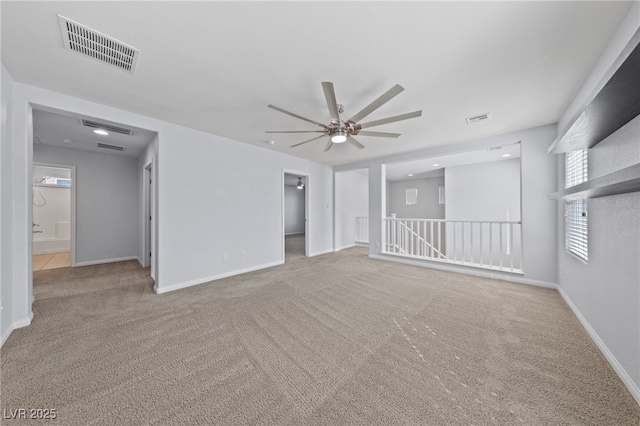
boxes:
[0,66,14,345]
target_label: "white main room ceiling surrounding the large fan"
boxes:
[0,1,631,165]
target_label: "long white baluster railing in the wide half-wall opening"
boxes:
[383,216,522,273]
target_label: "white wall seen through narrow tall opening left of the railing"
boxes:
[335,171,369,250]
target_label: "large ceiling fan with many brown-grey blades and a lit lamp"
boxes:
[266,81,422,152]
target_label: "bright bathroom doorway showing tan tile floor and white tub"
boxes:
[32,163,76,271]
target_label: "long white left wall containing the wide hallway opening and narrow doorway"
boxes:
[3,80,333,330]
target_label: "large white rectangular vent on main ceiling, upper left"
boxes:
[58,15,140,74]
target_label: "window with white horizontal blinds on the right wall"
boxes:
[564,150,589,262]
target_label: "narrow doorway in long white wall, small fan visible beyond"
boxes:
[282,171,309,262]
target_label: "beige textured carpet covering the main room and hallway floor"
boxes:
[1,243,640,425]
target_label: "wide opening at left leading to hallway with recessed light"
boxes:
[28,106,157,294]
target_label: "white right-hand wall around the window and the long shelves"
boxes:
[557,2,640,404]
